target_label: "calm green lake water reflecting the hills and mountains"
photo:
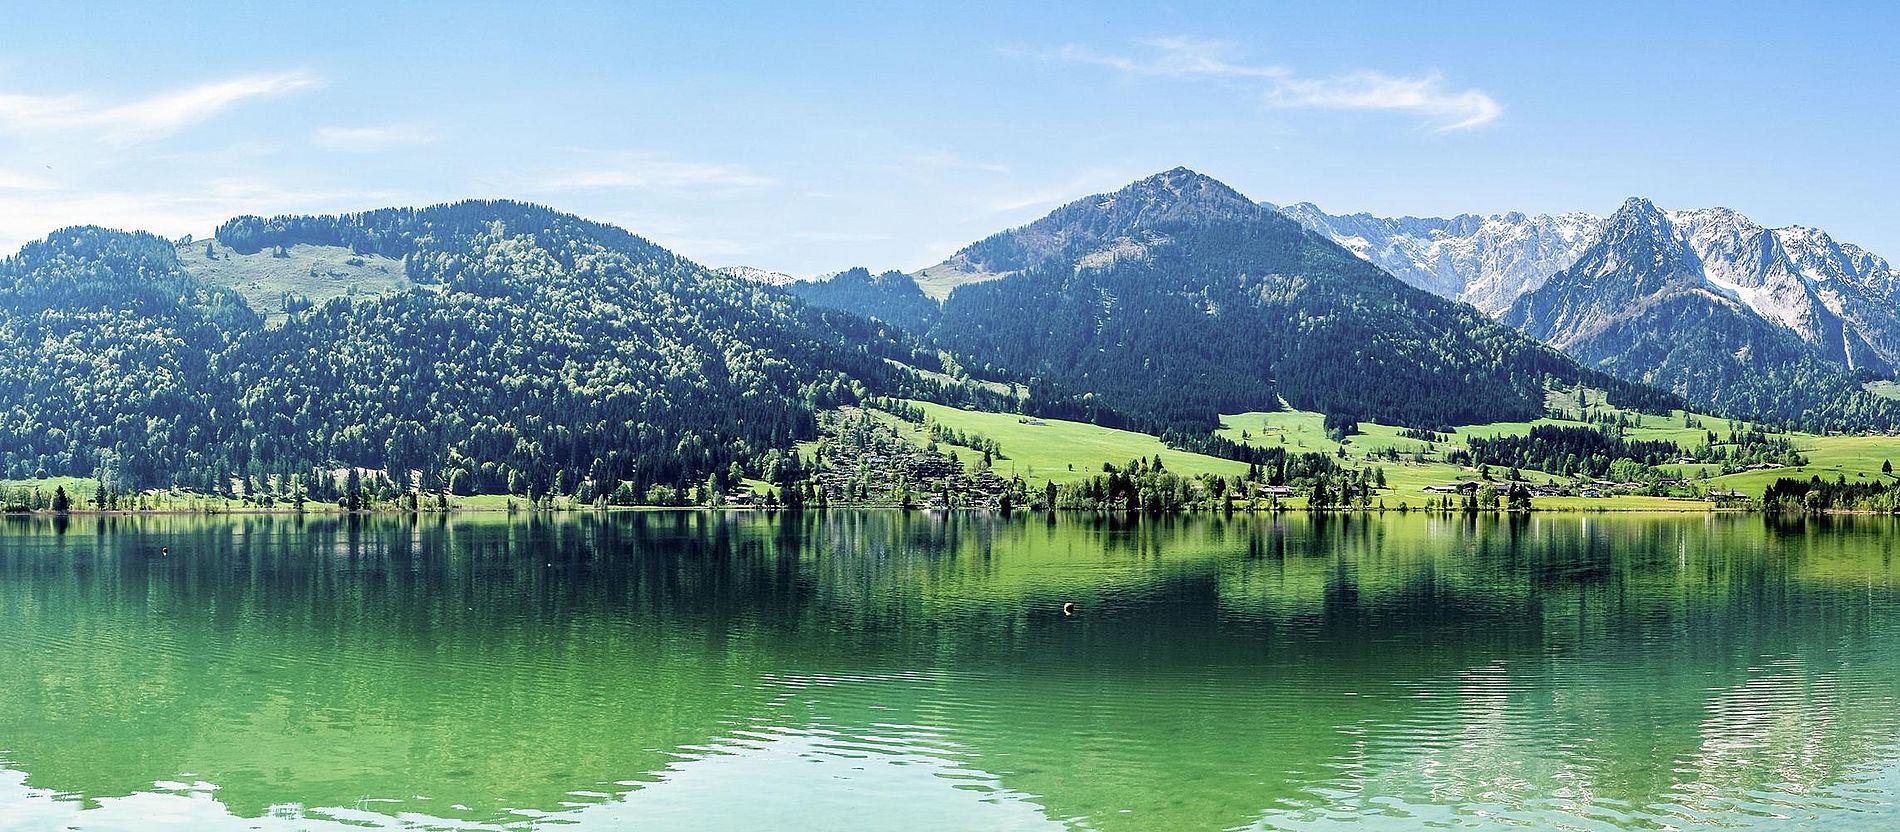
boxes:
[0,511,1900,832]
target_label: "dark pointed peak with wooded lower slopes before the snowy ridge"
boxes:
[1501,199,1896,427]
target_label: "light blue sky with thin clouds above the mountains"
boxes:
[0,2,1900,274]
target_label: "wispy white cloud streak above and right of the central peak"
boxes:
[1041,38,1505,131]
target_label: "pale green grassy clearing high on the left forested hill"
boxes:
[179,239,414,325]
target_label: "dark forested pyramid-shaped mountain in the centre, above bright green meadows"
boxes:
[925,169,1678,431]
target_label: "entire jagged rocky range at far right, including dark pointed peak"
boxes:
[1279,199,1900,427]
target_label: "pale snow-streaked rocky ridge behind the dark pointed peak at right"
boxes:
[1279,199,1900,367]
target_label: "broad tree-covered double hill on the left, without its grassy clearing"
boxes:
[0,201,931,496]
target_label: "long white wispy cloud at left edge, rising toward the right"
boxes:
[0,72,319,144]
